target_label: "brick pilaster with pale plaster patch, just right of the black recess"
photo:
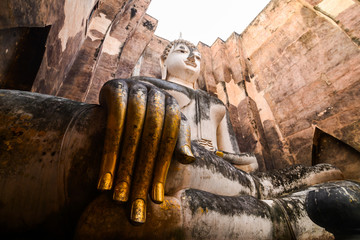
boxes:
[32,0,96,95]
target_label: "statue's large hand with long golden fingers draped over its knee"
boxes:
[94,80,195,223]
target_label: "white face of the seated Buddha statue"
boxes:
[164,43,201,86]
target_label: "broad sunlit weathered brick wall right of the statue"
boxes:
[242,0,360,167]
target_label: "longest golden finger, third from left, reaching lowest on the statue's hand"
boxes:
[130,89,165,223]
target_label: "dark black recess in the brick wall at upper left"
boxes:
[0,26,51,91]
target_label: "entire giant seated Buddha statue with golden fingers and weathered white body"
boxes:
[0,40,360,239]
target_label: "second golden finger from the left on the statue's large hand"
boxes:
[113,84,147,202]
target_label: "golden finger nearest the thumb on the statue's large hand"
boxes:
[151,97,181,203]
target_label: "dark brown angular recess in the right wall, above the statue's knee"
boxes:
[312,128,360,181]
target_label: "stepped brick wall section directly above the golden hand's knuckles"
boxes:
[48,0,157,103]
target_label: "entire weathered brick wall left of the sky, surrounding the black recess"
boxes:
[13,0,157,103]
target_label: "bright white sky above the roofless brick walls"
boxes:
[146,0,270,46]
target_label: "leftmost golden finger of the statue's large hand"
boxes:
[98,81,128,190]
